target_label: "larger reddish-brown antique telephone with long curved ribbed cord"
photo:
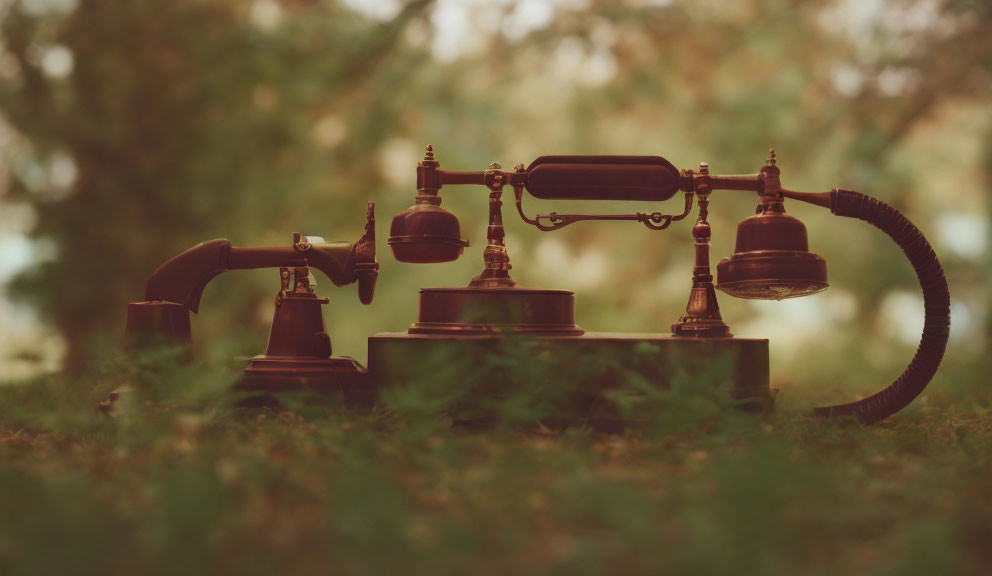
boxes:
[369,146,950,423]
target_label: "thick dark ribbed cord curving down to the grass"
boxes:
[816,189,951,424]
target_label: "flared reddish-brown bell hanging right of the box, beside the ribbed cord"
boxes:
[716,201,829,300]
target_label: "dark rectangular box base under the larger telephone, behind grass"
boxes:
[368,331,776,429]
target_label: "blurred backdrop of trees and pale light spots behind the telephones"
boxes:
[0,0,992,401]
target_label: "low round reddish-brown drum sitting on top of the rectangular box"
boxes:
[409,287,584,336]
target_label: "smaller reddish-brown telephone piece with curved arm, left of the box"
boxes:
[125,203,379,389]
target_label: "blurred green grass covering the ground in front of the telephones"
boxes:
[0,346,992,575]
